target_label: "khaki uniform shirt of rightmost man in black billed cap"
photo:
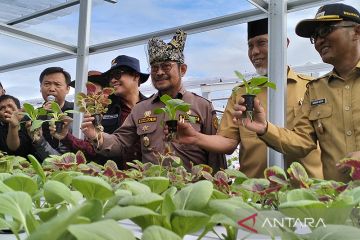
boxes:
[261,62,360,182]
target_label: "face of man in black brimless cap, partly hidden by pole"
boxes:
[248,34,268,75]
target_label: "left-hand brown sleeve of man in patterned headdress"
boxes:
[95,109,139,157]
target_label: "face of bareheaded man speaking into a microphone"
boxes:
[40,73,70,105]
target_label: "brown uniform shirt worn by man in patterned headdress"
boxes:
[98,88,226,171]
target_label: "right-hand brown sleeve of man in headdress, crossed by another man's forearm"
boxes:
[202,99,227,174]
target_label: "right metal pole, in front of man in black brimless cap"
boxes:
[268,0,287,168]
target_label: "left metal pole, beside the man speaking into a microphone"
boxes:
[73,0,92,138]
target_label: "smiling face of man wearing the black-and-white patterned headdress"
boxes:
[150,61,186,92]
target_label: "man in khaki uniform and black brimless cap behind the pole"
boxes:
[173,19,323,178]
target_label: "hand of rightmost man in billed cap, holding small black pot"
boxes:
[233,97,267,135]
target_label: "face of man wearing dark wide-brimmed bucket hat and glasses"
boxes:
[109,69,140,97]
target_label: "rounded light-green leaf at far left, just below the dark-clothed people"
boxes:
[3,175,38,196]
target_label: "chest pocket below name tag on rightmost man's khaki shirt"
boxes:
[309,105,334,138]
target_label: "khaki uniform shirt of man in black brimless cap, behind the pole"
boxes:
[218,68,323,178]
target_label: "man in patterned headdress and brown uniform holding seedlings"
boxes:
[82,30,226,171]
